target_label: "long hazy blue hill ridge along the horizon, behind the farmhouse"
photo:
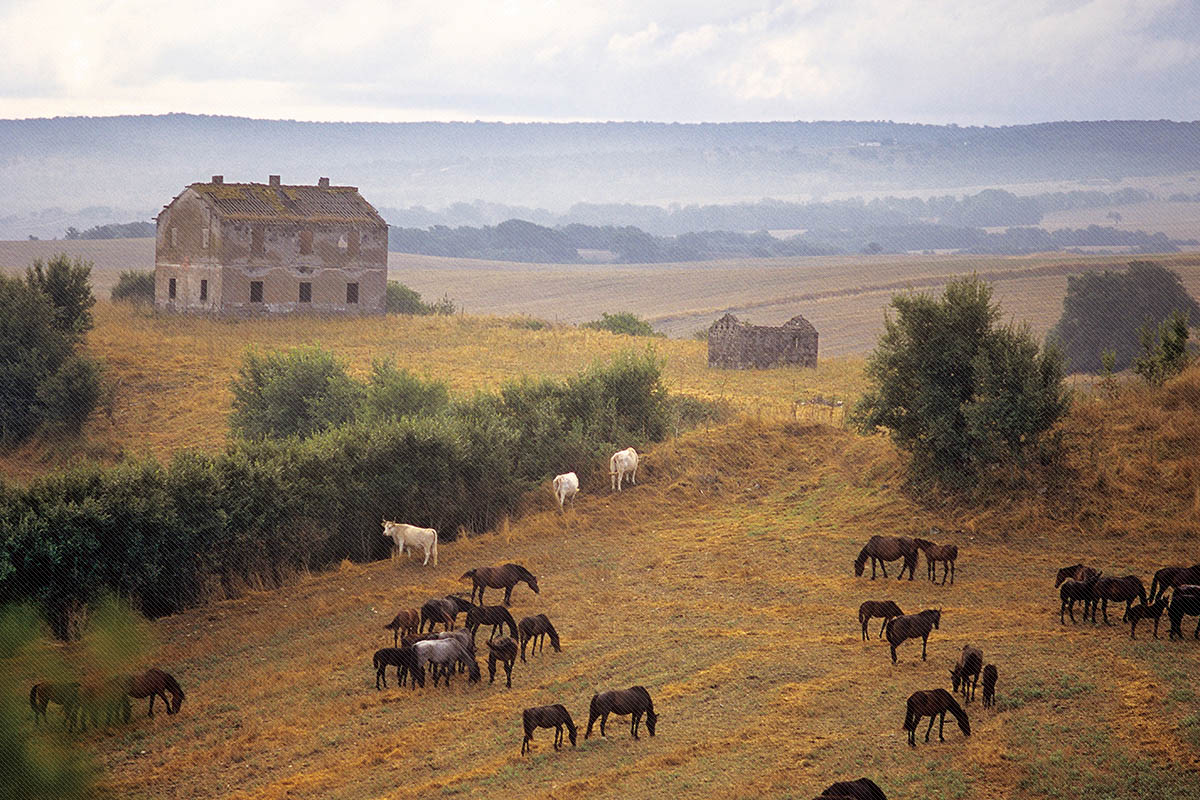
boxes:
[7,114,1200,236]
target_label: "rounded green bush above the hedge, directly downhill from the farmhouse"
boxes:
[229,347,362,439]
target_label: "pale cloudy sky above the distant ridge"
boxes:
[0,0,1200,125]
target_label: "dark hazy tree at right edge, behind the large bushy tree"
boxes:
[1050,261,1200,373]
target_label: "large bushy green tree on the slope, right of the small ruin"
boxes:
[854,277,1069,488]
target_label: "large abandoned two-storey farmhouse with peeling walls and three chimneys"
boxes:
[155,175,388,315]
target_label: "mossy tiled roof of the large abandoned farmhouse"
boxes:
[164,176,388,225]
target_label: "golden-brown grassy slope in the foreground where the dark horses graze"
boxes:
[16,369,1200,799]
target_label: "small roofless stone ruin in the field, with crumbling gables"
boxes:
[708,314,817,369]
